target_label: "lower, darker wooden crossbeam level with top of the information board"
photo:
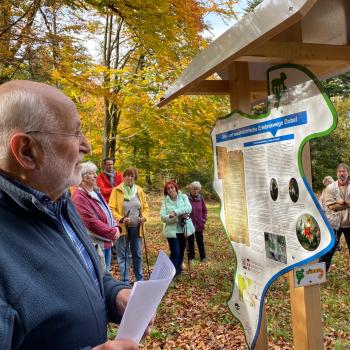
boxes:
[185,80,267,95]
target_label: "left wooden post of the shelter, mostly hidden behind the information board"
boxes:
[228,62,268,350]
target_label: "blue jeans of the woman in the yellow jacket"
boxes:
[117,227,143,284]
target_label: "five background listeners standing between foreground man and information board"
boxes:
[71,158,207,285]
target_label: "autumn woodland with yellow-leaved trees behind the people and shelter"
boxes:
[0,0,350,194]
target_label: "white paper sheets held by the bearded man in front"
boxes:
[116,251,175,343]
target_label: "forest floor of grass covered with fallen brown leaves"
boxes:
[110,196,350,350]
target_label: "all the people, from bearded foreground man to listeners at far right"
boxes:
[0,80,350,350]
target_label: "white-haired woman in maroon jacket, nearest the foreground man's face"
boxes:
[72,162,120,271]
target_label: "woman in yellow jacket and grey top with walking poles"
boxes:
[109,168,148,284]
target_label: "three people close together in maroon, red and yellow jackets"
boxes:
[72,158,148,285]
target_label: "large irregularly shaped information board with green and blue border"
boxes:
[211,65,337,348]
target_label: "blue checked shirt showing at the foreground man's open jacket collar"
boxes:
[10,179,100,291]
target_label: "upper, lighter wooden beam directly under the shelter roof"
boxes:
[237,41,350,66]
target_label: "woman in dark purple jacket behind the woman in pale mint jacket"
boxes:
[188,181,208,262]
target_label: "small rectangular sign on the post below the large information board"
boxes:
[294,262,326,287]
